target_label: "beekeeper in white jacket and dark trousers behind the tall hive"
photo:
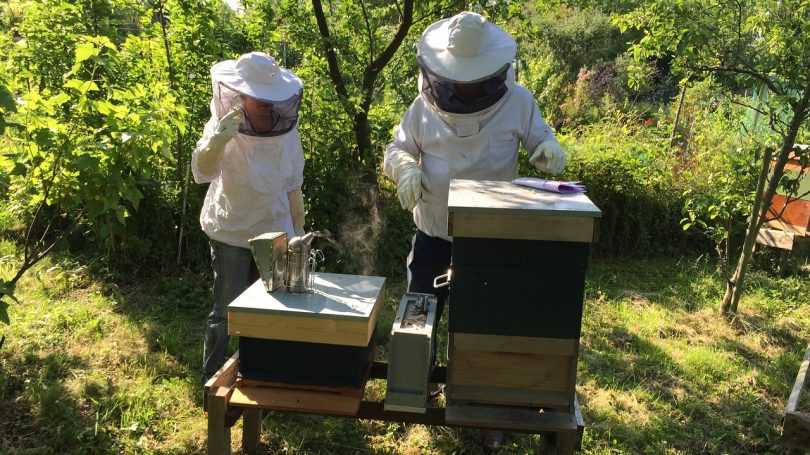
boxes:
[384,12,567,447]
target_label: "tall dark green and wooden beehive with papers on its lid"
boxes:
[447,180,601,411]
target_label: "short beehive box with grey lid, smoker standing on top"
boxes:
[228,273,385,387]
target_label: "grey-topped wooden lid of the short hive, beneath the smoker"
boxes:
[228,273,385,346]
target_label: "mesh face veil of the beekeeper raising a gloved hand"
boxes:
[214,83,303,136]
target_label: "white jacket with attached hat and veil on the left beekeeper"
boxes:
[191,52,304,248]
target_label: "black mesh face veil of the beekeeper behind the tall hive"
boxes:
[418,58,509,114]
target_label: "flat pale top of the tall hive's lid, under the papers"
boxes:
[448,179,602,218]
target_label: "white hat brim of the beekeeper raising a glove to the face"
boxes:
[211,60,304,101]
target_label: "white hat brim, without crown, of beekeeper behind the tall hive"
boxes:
[417,19,517,82]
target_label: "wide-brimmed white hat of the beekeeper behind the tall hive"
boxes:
[417,12,517,82]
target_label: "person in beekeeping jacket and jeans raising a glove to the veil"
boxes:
[191,52,304,380]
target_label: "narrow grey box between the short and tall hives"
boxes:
[384,292,437,413]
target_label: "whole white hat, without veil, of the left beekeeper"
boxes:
[211,52,304,101]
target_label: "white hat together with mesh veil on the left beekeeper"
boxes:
[211,52,304,136]
